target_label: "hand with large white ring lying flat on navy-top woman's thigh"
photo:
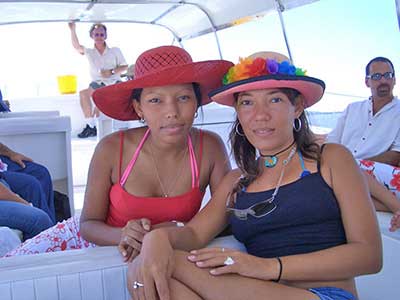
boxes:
[188,248,279,280]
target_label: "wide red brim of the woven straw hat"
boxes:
[93,60,233,121]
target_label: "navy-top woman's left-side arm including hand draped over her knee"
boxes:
[128,171,240,299]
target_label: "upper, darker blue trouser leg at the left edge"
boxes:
[0,156,56,223]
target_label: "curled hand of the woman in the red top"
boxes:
[118,218,151,262]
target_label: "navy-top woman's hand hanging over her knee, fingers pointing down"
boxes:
[127,230,174,300]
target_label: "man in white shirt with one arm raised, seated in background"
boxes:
[68,22,128,138]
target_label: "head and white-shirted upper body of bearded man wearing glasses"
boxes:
[327,57,400,166]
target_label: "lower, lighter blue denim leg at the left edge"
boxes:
[0,200,53,240]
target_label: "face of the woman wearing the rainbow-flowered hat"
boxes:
[236,89,303,154]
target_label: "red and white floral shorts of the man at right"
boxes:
[356,159,400,199]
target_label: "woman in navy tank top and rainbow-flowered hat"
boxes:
[128,52,382,300]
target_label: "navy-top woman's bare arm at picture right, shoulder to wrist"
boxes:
[274,144,382,281]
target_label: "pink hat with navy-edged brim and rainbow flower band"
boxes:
[209,52,325,108]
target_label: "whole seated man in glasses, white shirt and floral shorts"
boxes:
[326,57,400,218]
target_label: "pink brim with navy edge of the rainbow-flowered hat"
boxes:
[209,74,325,108]
